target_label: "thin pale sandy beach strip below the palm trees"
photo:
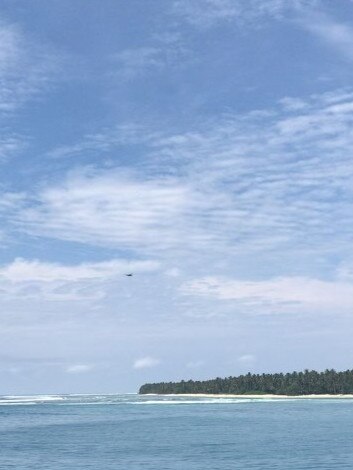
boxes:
[140,393,353,400]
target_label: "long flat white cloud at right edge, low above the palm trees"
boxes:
[182,277,353,314]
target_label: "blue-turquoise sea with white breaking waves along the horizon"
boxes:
[0,395,353,470]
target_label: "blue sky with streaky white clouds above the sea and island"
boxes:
[0,0,353,394]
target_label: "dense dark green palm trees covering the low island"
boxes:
[139,369,353,395]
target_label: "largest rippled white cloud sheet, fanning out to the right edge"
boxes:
[4,90,353,264]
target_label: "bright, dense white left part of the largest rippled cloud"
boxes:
[13,170,226,252]
